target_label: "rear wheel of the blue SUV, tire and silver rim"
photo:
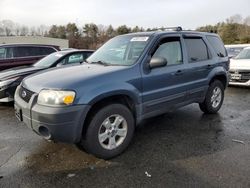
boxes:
[199,80,225,114]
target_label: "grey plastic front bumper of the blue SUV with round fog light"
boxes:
[15,86,90,143]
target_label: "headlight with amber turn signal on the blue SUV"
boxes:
[37,90,75,106]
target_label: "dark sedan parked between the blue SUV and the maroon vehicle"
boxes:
[0,50,94,102]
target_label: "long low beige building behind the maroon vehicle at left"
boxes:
[0,36,69,49]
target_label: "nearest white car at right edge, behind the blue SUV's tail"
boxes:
[229,47,250,86]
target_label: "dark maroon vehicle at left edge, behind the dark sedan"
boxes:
[0,44,60,71]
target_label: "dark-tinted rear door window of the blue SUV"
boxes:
[184,38,209,63]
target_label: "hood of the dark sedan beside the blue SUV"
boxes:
[0,66,44,80]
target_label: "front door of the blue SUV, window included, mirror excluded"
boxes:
[142,35,187,117]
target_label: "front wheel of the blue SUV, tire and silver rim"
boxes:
[79,104,135,159]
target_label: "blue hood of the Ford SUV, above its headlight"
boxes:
[22,64,127,93]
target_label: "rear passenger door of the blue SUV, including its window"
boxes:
[183,35,215,102]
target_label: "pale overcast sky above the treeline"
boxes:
[0,0,250,29]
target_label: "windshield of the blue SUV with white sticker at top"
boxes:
[87,35,149,66]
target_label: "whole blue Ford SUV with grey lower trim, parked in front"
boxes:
[15,30,229,159]
